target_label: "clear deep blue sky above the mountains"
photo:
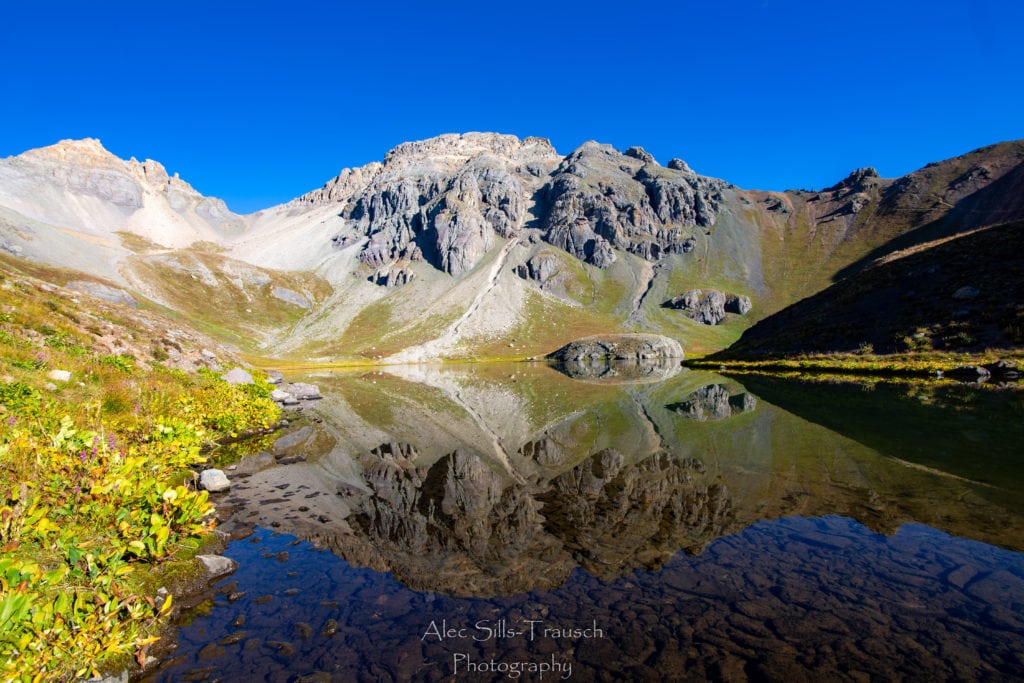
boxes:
[0,0,1024,212]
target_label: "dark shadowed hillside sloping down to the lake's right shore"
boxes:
[721,222,1024,357]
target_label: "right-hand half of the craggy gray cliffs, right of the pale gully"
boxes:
[542,142,726,267]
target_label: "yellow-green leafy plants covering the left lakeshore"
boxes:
[0,358,278,681]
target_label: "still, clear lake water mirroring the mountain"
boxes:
[150,364,1024,682]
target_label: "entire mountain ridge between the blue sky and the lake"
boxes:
[0,133,1024,361]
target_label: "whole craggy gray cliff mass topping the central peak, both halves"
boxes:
[299,133,726,278]
